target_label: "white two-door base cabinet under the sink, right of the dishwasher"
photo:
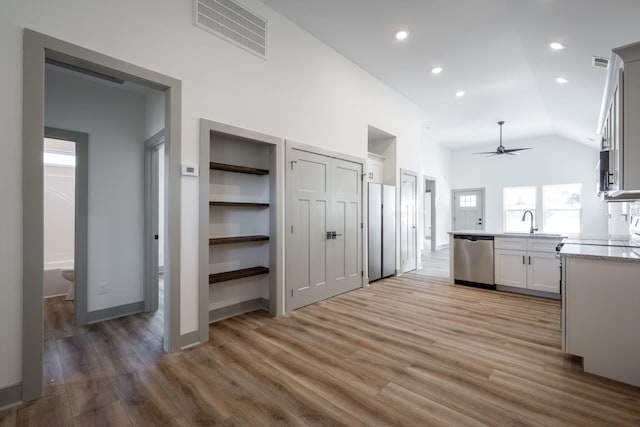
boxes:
[494,237,560,294]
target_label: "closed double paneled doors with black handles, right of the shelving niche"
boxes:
[286,148,362,311]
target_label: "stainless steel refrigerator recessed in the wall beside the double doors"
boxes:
[368,182,396,282]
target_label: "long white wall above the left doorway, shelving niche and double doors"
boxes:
[0,0,428,388]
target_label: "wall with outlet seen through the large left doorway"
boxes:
[45,67,145,311]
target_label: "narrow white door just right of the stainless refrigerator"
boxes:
[400,172,418,273]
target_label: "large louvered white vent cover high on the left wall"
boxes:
[194,0,267,59]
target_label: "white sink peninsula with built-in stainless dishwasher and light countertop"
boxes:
[449,230,564,299]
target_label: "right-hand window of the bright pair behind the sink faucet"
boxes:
[542,184,582,233]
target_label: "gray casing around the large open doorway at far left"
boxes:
[22,29,181,402]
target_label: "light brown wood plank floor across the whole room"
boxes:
[0,266,640,426]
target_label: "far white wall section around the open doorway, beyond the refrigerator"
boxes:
[418,139,452,248]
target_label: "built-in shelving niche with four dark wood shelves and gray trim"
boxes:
[200,120,282,330]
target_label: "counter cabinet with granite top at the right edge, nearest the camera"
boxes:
[560,240,640,386]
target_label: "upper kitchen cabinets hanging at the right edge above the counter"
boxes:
[598,42,640,201]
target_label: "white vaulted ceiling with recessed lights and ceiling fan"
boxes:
[262,0,640,148]
